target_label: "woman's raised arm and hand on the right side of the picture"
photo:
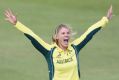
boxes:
[72,6,112,52]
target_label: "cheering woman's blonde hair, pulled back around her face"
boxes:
[52,24,72,44]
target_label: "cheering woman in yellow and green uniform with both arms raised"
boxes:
[5,6,112,80]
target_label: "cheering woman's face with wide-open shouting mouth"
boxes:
[56,27,71,49]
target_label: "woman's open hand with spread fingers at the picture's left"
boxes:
[4,9,17,25]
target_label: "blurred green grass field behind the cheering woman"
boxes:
[0,0,119,80]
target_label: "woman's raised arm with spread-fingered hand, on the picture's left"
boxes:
[4,10,51,55]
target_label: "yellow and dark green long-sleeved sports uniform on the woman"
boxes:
[15,17,108,80]
